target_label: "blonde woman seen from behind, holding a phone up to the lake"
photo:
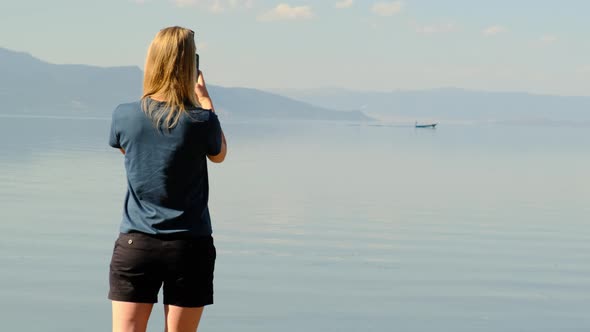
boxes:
[109,27,227,332]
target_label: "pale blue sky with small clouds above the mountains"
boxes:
[0,0,590,96]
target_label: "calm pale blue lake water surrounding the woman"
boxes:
[0,116,590,332]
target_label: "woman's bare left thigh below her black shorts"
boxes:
[112,301,154,332]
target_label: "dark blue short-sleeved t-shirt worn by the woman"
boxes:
[109,98,221,237]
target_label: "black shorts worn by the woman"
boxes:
[109,233,216,307]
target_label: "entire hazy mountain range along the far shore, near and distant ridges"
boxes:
[0,48,590,124]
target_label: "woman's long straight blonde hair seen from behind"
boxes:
[142,26,199,129]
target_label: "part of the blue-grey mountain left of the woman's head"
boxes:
[0,48,142,116]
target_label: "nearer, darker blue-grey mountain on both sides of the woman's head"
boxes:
[0,48,371,121]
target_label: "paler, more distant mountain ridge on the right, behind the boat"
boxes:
[276,88,590,124]
